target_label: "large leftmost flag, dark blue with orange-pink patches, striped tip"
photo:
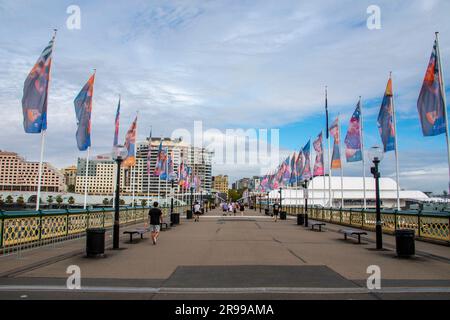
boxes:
[22,36,55,133]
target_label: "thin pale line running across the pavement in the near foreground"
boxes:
[0,286,450,294]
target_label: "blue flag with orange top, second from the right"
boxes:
[377,78,395,152]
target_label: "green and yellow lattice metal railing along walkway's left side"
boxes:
[0,205,189,254]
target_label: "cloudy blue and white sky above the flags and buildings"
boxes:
[0,0,450,192]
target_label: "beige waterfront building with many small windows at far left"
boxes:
[0,150,66,192]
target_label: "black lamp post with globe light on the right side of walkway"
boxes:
[369,146,384,250]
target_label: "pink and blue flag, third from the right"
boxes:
[344,101,362,162]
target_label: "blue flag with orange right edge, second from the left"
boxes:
[73,73,95,151]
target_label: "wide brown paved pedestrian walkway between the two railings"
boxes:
[0,209,450,299]
